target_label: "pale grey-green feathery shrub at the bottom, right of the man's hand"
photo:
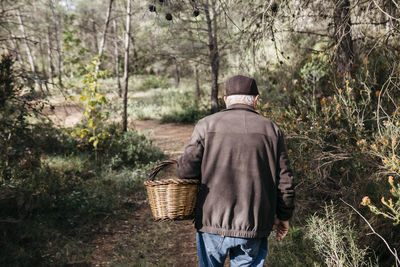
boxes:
[306,204,376,267]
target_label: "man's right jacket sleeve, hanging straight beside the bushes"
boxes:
[276,130,295,221]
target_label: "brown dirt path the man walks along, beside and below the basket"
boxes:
[91,120,197,267]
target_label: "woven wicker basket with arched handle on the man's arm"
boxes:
[144,160,199,221]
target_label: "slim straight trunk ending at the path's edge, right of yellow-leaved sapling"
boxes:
[122,0,131,132]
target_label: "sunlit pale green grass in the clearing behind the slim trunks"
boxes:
[49,75,209,123]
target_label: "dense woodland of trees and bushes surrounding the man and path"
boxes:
[0,0,400,266]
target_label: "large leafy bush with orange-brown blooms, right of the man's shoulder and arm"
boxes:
[261,49,400,264]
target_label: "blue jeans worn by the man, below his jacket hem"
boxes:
[196,232,268,267]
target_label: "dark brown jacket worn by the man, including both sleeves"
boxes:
[178,104,293,238]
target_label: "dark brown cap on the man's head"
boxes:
[225,75,259,96]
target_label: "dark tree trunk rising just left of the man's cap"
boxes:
[204,0,219,113]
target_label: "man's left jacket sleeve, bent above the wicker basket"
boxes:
[176,122,204,179]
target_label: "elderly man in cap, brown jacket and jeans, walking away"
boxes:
[177,75,294,266]
